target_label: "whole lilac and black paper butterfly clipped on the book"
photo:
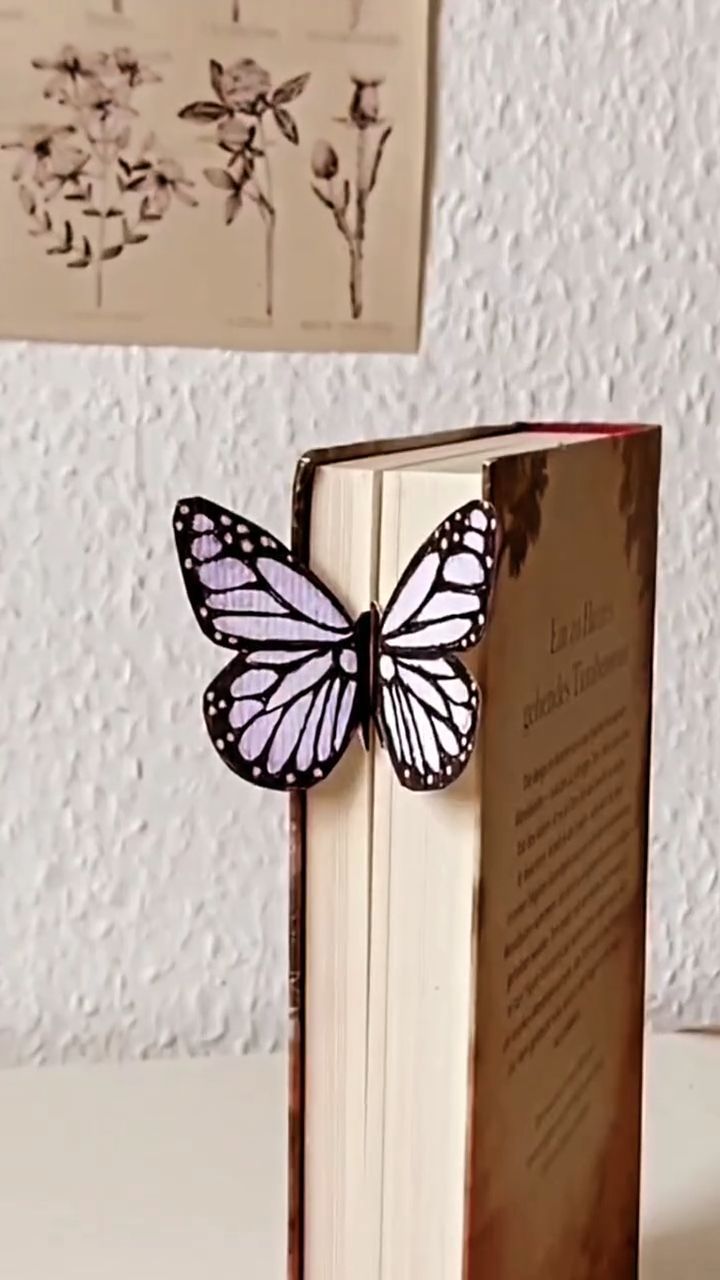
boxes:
[174,498,498,791]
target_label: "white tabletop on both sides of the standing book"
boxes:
[0,1036,720,1280]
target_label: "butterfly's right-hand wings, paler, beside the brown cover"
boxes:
[375,500,498,791]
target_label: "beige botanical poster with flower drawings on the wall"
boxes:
[0,0,429,351]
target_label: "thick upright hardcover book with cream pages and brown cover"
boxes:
[284,424,660,1280]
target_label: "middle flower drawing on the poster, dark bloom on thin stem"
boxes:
[179,58,310,317]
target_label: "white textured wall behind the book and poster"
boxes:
[0,0,720,1064]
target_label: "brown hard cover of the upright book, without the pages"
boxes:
[284,424,660,1280]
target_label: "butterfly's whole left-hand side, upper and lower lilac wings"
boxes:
[174,498,359,790]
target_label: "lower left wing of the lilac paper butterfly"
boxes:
[204,644,359,791]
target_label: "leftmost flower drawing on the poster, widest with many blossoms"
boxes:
[3,45,197,307]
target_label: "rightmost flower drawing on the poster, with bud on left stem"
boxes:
[310,78,392,320]
